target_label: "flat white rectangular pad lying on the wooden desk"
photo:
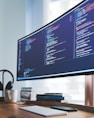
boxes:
[20,105,67,116]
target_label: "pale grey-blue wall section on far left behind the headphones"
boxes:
[0,0,26,98]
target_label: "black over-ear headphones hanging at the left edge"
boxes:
[0,69,14,91]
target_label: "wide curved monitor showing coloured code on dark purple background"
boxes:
[17,0,94,80]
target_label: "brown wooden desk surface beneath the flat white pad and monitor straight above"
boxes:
[0,102,94,118]
